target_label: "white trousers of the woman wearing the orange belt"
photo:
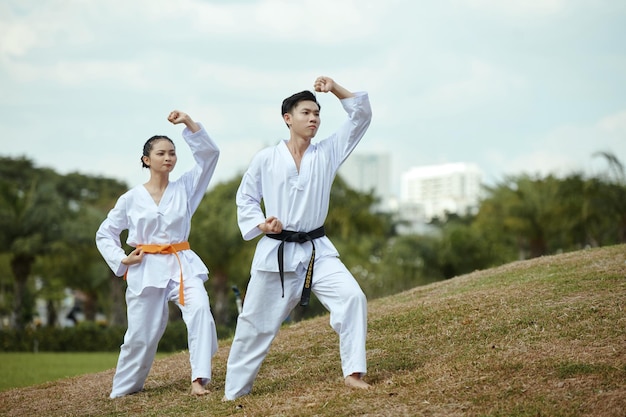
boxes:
[110,277,217,398]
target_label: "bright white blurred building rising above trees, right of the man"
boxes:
[400,163,482,229]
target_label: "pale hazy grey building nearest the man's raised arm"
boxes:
[339,153,392,211]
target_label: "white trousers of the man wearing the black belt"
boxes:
[225,257,367,400]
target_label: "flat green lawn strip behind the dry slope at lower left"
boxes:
[0,352,169,391]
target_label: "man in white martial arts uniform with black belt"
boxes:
[224,76,372,400]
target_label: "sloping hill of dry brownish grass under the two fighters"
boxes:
[0,245,626,417]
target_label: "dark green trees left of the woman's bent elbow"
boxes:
[0,157,126,329]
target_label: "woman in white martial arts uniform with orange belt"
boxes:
[96,110,219,398]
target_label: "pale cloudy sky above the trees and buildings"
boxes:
[0,0,626,198]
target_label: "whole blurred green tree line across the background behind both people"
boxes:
[0,153,626,330]
